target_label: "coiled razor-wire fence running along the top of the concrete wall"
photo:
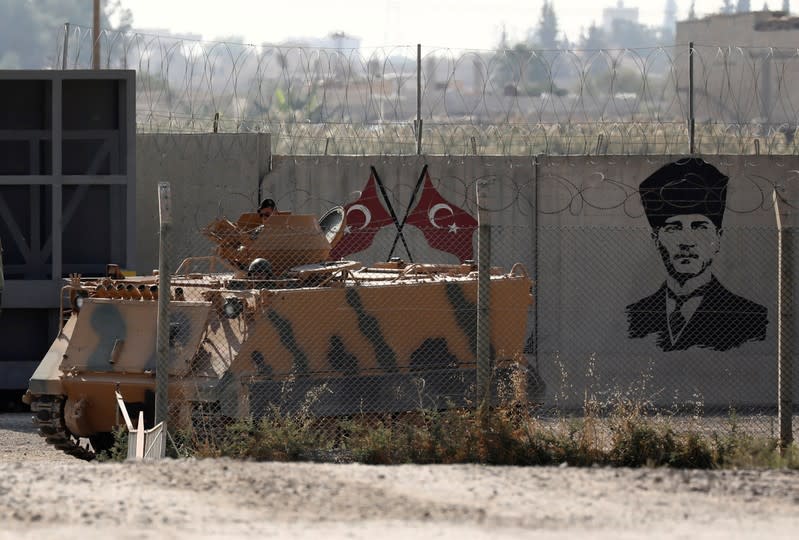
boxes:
[54,24,799,156]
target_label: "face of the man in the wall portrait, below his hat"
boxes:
[653,214,722,282]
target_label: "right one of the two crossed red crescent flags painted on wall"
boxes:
[405,171,477,262]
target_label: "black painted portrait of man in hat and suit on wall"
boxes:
[626,158,768,351]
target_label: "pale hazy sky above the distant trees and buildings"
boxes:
[122,0,744,49]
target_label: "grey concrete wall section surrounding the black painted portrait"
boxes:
[537,156,799,407]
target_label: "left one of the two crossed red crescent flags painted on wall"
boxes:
[330,173,394,260]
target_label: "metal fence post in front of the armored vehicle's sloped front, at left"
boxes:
[155,182,172,425]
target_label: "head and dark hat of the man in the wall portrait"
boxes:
[639,158,729,283]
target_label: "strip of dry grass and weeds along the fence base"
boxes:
[167,392,799,469]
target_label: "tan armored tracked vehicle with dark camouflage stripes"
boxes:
[24,207,537,459]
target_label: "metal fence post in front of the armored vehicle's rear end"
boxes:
[476,180,491,408]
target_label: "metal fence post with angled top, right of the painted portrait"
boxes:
[774,190,794,449]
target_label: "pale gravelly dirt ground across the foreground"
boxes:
[0,413,799,540]
